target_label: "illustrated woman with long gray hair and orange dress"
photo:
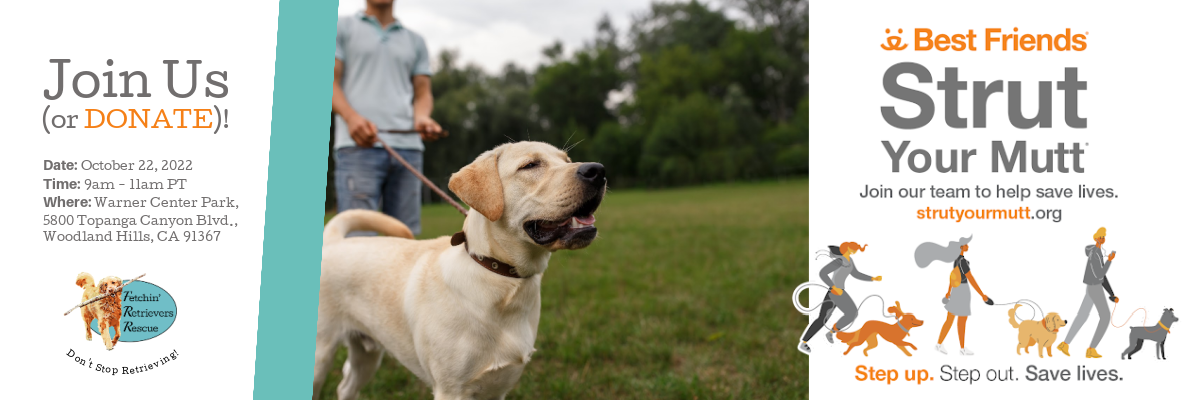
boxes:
[916,238,990,356]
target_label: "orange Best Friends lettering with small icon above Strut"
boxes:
[880,26,1088,52]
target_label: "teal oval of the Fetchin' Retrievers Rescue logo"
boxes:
[91,281,178,342]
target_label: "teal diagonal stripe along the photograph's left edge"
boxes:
[254,0,337,399]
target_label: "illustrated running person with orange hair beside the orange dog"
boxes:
[799,241,883,354]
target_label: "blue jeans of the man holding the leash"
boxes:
[334,147,424,237]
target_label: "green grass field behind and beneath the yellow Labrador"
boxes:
[323,180,809,400]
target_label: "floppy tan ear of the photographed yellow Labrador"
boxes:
[450,149,504,222]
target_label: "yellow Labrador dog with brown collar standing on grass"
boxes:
[313,142,607,400]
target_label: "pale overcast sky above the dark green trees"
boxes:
[337,0,667,72]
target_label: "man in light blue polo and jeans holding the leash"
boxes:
[334,0,445,234]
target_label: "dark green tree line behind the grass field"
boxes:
[328,0,809,202]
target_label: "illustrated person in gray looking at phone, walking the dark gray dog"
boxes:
[1058,227,1121,358]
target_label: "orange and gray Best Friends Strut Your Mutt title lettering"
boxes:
[880,28,1088,173]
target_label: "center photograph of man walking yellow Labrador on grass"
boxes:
[313,0,808,399]
